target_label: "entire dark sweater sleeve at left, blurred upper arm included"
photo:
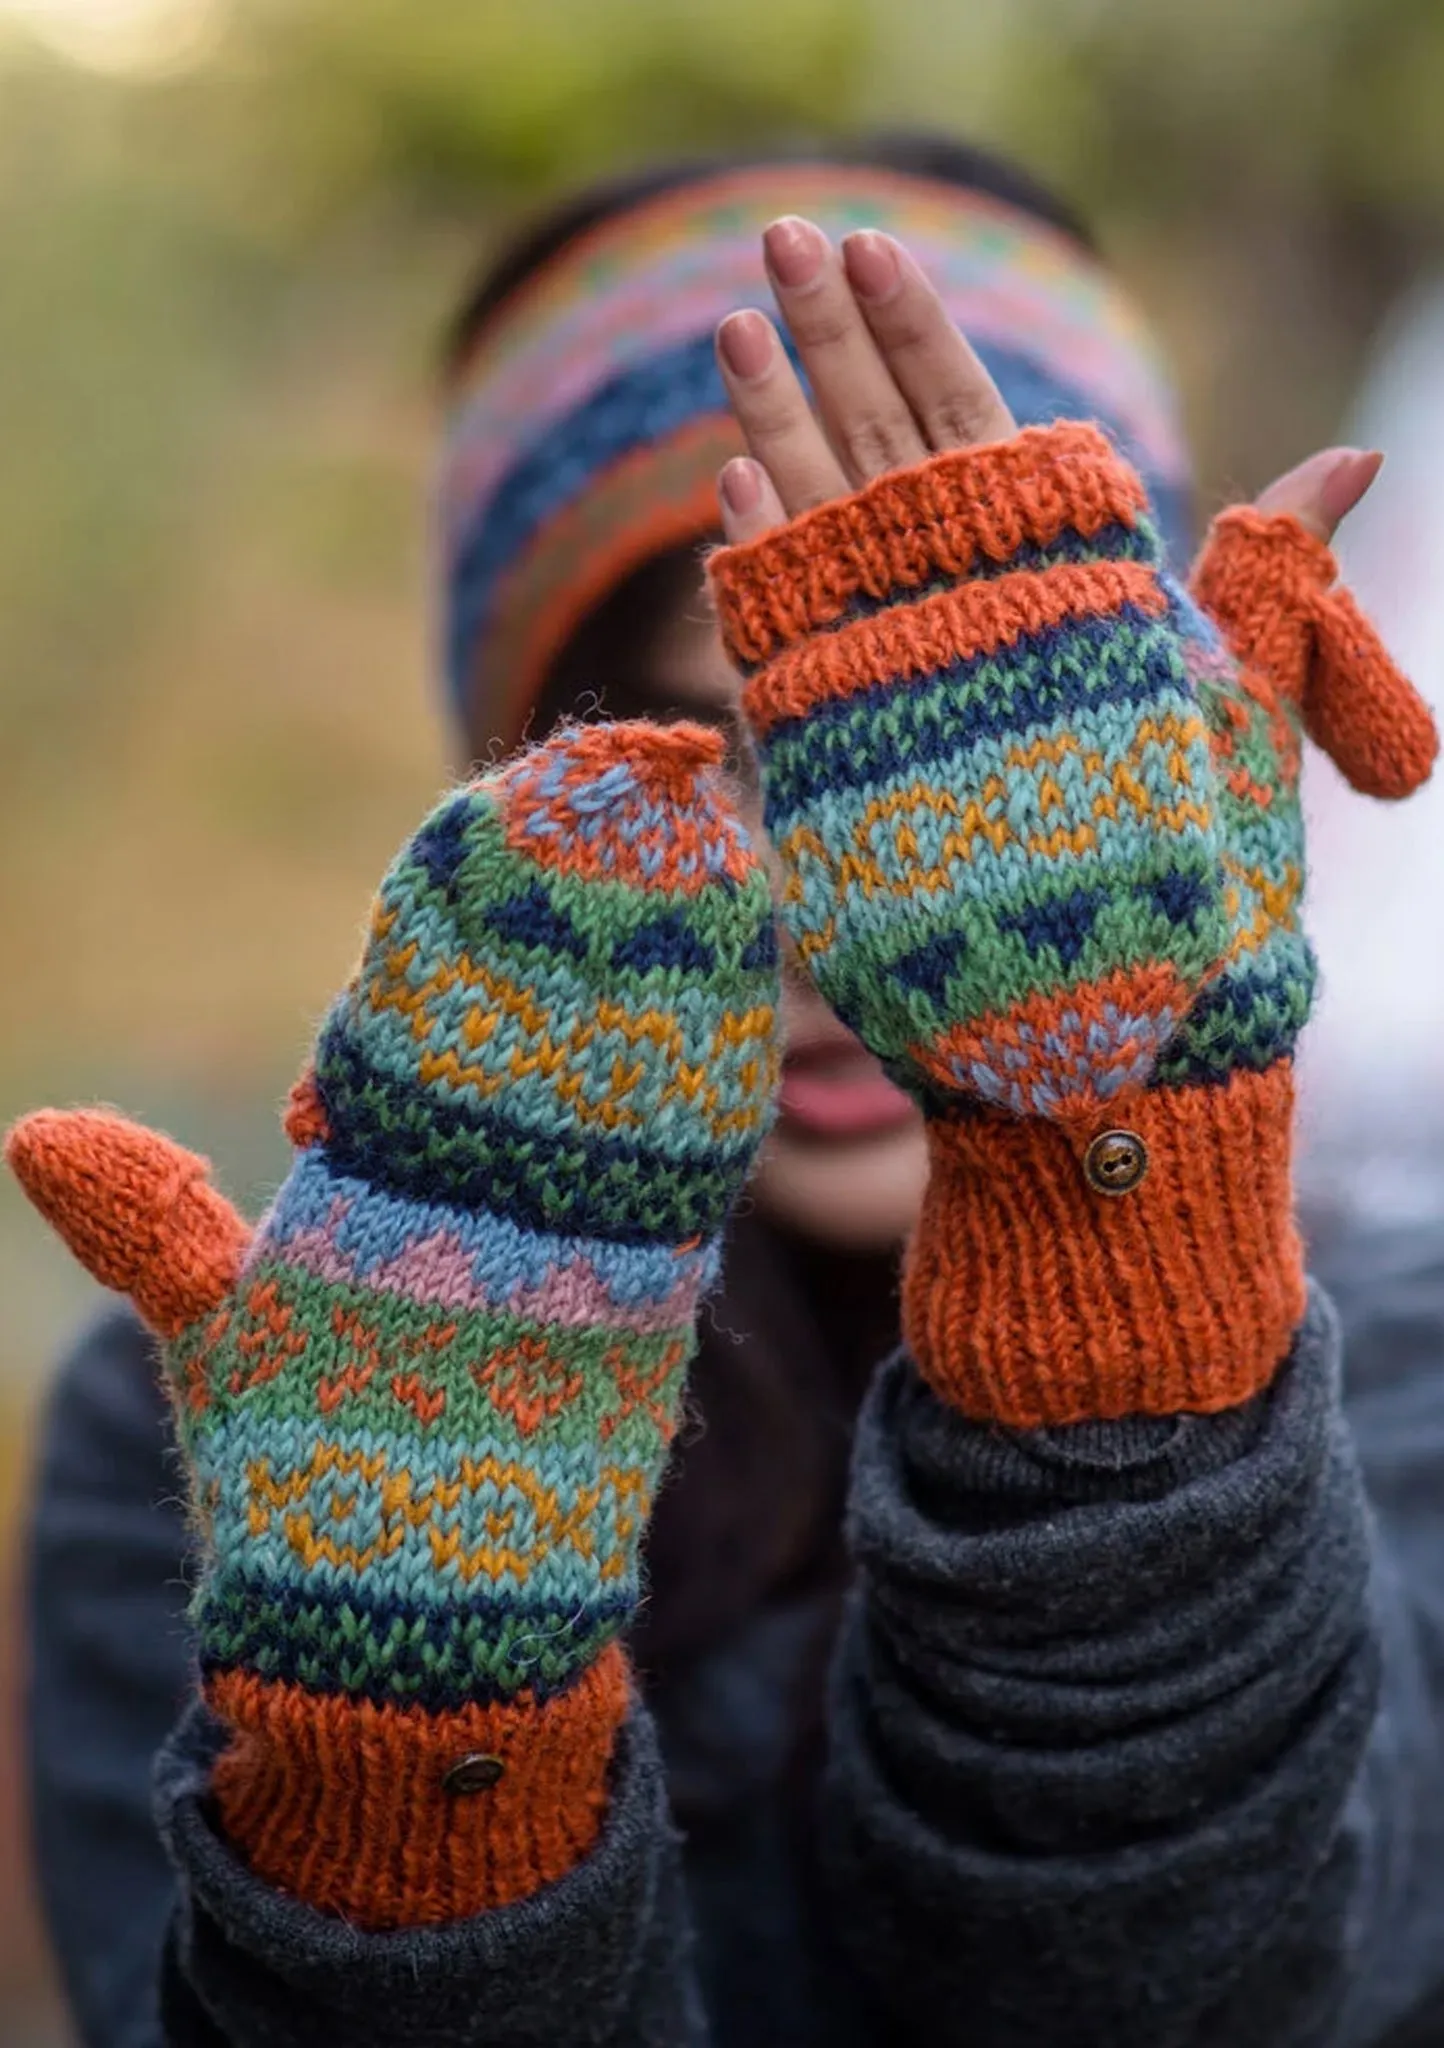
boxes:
[27,1313,705,2048]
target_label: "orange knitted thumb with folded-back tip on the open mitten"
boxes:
[1192,506,1438,799]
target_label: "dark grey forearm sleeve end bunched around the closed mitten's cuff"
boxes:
[156,1704,705,2048]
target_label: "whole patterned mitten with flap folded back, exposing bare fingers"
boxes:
[711,424,1434,1427]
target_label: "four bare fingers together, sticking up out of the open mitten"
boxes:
[717,217,1016,545]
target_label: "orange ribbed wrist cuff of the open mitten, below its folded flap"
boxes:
[903,1061,1305,1430]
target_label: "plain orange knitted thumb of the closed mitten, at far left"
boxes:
[4,1110,250,1339]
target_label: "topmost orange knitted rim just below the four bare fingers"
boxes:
[709,420,1147,668]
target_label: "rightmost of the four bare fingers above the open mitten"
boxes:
[842,229,1016,449]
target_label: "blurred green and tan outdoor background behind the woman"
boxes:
[0,0,1444,2044]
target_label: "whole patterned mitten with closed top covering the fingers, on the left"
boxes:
[6,725,778,1927]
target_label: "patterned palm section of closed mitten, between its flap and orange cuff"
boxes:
[182,1149,715,1708]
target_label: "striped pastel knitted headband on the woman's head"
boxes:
[440,164,1188,745]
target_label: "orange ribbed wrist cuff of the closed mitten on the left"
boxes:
[207,1642,631,1931]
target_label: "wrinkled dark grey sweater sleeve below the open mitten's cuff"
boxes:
[825,1290,1444,2048]
